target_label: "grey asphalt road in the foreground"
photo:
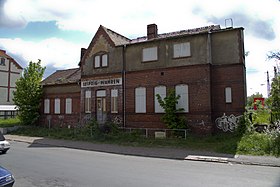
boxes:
[0,142,280,187]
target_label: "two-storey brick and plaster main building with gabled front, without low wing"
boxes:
[40,24,246,133]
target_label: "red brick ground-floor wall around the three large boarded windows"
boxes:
[126,65,212,131]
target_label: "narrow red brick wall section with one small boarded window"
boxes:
[211,64,246,131]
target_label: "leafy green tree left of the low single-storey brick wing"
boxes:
[14,60,45,125]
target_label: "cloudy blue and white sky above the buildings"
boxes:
[0,0,280,97]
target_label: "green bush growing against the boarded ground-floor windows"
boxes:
[156,89,186,129]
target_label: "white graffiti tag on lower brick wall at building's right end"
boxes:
[215,113,241,132]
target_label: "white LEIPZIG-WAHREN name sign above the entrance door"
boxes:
[81,78,122,88]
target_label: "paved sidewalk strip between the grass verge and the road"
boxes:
[5,134,280,167]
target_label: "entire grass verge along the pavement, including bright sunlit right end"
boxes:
[9,127,280,157]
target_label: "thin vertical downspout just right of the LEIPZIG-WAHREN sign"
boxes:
[122,44,126,128]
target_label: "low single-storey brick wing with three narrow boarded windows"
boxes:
[41,68,81,126]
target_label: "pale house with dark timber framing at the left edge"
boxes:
[0,49,22,119]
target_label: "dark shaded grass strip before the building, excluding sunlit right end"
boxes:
[12,127,245,154]
